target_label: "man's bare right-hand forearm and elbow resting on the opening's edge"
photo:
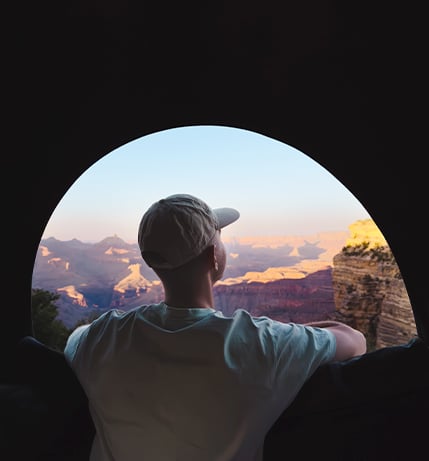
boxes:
[305,320,366,361]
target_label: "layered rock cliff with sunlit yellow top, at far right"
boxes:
[332,220,416,350]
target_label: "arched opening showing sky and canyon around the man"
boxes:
[32,125,416,350]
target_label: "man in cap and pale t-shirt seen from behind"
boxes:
[65,194,366,461]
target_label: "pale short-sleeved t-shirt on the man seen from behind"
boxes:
[64,303,336,461]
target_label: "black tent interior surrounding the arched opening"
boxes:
[4,0,429,461]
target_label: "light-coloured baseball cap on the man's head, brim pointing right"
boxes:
[138,194,240,269]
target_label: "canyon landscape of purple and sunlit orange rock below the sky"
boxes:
[33,220,416,350]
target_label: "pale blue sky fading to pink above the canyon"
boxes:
[43,126,370,243]
